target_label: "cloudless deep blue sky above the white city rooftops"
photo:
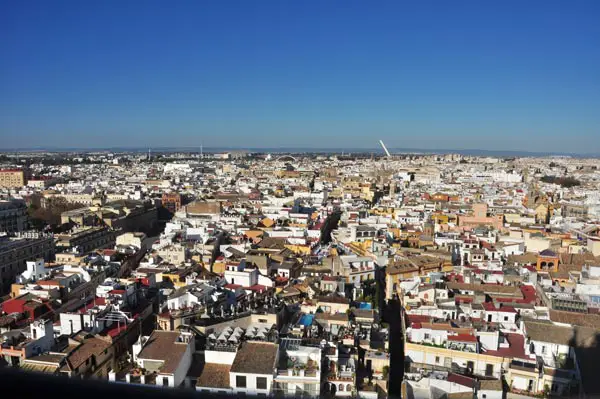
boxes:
[0,0,600,153]
